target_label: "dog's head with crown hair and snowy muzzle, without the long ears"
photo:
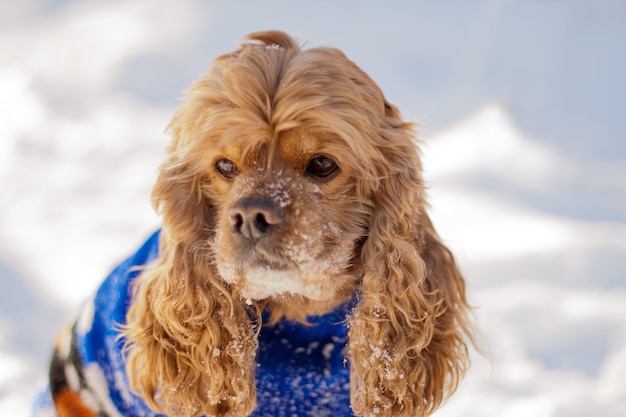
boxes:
[161,41,394,307]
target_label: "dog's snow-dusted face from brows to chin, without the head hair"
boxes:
[209,125,364,300]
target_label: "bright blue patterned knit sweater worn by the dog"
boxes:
[34,232,353,417]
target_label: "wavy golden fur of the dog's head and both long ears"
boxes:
[124,32,472,417]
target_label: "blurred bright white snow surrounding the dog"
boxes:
[0,0,626,417]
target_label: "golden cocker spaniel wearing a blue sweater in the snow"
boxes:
[37,31,473,417]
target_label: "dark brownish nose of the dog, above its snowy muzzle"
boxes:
[228,197,283,240]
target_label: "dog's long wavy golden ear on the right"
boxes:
[349,101,472,417]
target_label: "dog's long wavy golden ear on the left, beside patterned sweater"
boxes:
[123,156,257,416]
